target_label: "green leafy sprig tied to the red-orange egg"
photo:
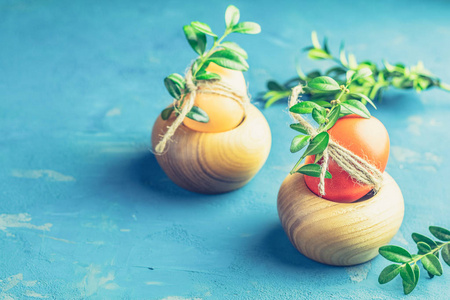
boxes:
[289,68,376,178]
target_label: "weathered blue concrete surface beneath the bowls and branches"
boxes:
[0,0,450,300]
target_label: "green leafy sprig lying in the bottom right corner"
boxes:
[378,226,450,295]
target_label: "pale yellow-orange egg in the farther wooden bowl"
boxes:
[183,63,247,132]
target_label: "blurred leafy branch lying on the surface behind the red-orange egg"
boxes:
[263,31,450,108]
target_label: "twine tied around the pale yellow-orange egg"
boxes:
[155,65,249,155]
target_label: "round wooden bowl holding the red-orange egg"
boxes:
[278,172,404,266]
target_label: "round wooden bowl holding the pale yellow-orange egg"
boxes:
[152,104,272,194]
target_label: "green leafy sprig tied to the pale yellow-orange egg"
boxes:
[161,5,261,123]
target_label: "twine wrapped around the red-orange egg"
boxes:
[289,85,383,196]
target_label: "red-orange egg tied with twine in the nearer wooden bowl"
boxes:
[305,115,389,202]
